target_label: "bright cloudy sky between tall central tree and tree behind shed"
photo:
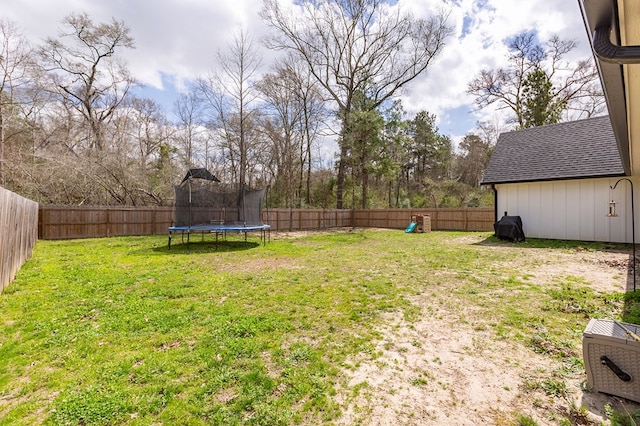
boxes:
[401,0,591,145]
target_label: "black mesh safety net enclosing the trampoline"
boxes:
[174,180,266,227]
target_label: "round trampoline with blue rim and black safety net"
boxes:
[168,169,271,249]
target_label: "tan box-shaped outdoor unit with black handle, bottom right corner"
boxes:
[582,319,640,402]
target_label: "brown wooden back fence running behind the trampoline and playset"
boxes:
[38,206,494,240]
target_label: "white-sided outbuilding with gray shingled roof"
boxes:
[481,116,635,242]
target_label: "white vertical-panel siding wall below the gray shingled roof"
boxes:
[496,177,640,243]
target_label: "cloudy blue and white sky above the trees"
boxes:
[0,0,591,155]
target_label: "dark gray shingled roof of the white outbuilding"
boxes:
[482,116,624,185]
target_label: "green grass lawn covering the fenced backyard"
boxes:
[0,230,640,425]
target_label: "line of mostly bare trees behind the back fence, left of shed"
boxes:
[0,0,600,208]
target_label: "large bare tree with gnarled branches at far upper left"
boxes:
[40,14,135,151]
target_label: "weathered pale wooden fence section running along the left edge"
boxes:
[0,187,38,293]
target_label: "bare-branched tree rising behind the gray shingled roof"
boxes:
[467,31,605,128]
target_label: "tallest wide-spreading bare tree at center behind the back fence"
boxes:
[261,0,451,208]
